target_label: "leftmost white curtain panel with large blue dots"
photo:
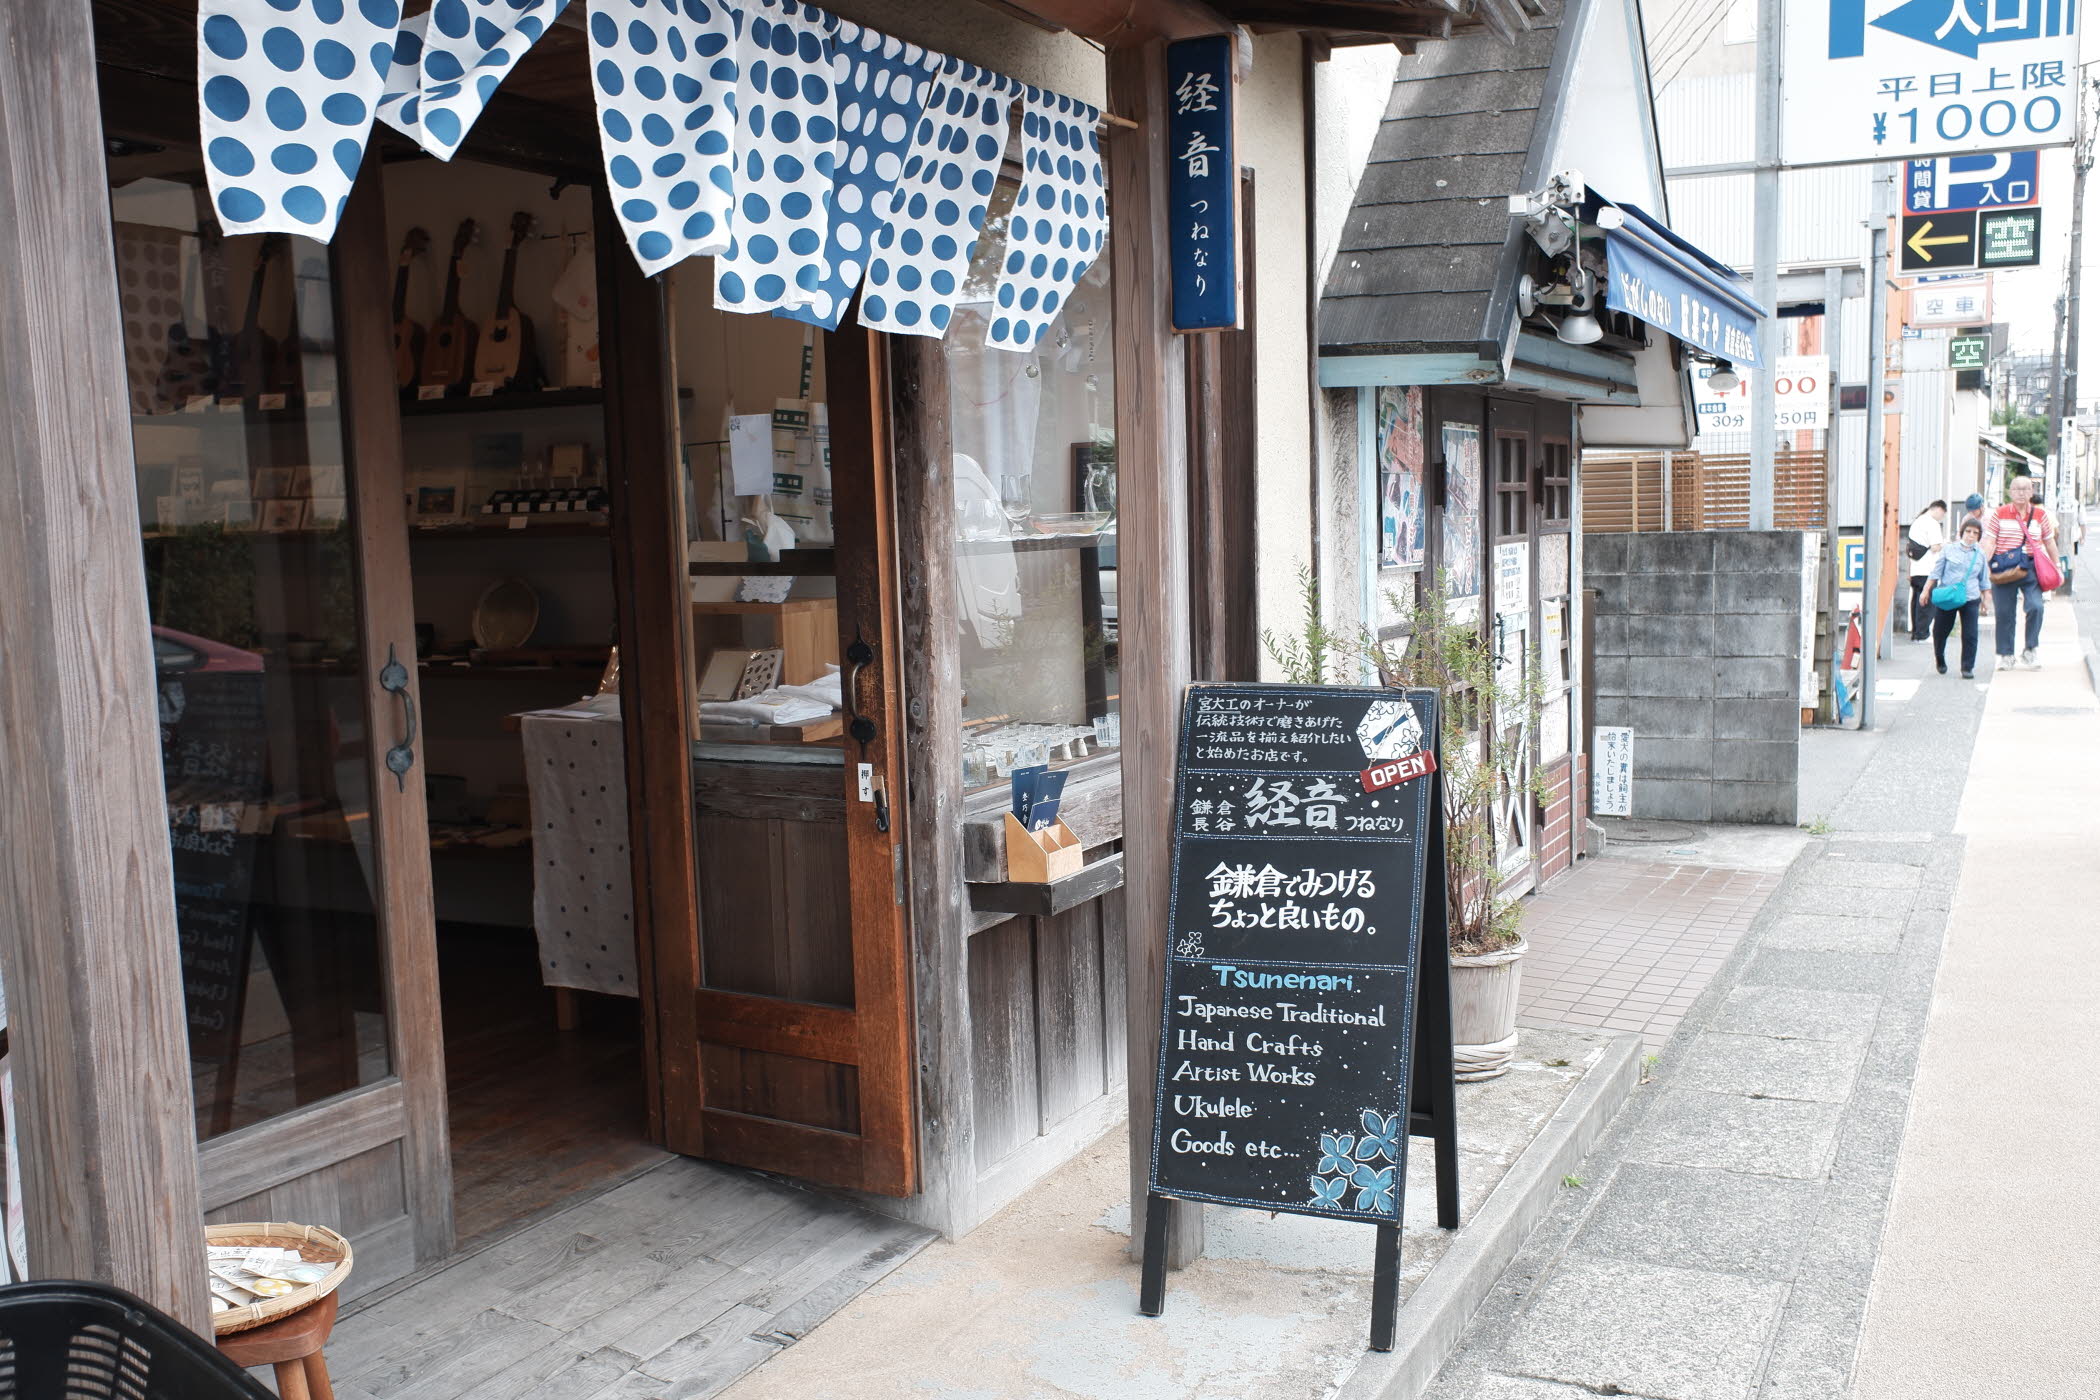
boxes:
[197,0,401,241]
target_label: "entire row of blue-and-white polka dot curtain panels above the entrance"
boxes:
[200,0,1107,353]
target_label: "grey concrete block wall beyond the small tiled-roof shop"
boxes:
[1583,531,1802,825]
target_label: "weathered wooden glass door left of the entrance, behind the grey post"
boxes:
[103,107,452,1289]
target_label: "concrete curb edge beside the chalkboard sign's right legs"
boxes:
[1336,1033,1640,1400]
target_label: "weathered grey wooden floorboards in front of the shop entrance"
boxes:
[328,1159,935,1400]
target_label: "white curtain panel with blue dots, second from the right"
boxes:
[861,59,1021,336]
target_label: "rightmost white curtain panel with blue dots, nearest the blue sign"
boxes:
[985,88,1109,351]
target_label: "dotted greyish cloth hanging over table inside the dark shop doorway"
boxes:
[519,713,641,997]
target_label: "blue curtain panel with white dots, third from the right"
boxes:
[775,21,943,330]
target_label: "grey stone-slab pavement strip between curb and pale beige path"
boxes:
[1426,835,1964,1400]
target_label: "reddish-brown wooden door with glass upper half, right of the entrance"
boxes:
[638,272,918,1196]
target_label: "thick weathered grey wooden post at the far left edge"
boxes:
[0,0,210,1333]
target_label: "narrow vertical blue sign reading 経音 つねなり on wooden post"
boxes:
[1166,34,1239,330]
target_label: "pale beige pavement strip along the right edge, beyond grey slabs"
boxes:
[1856,602,2100,1400]
